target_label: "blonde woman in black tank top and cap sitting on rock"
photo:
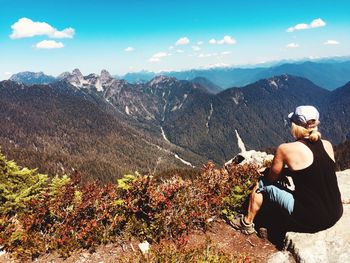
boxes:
[230,106,343,234]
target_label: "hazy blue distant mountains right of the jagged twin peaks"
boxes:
[121,60,350,90]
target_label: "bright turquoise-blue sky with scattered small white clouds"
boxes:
[0,0,350,79]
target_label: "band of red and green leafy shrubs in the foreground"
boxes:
[0,150,258,258]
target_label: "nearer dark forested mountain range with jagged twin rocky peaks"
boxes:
[0,69,350,181]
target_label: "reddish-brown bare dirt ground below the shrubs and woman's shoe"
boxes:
[0,221,284,263]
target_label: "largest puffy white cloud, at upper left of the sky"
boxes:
[10,17,75,39]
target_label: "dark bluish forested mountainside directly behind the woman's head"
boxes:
[164,75,330,163]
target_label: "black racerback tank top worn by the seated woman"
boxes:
[290,139,343,232]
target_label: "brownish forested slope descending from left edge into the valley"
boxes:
[0,81,202,182]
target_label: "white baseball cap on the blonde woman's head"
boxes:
[288,105,320,128]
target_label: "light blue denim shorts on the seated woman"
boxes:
[257,177,294,215]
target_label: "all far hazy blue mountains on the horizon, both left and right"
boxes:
[10,57,350,93]
